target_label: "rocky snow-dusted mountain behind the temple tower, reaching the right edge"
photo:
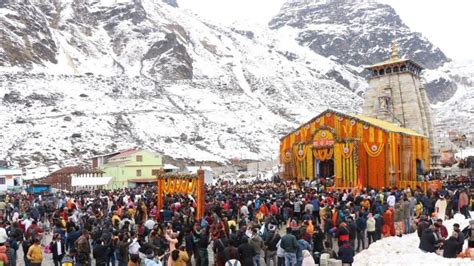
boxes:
[269,0,474,146]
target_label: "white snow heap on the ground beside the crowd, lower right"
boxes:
[353,212,474,266]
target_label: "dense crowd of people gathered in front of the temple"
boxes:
[0,176,474,266]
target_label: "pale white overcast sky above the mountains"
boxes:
[178,0,474,61]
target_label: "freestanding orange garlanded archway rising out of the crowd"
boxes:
[157,169,206,220]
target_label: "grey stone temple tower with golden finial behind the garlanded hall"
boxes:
[362,43,439,167]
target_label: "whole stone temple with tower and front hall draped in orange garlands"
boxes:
[280,44,435,188]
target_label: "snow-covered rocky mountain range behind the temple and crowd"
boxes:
[0,0,469,168]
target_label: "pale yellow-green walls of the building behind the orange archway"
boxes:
[102,150,163,189]
